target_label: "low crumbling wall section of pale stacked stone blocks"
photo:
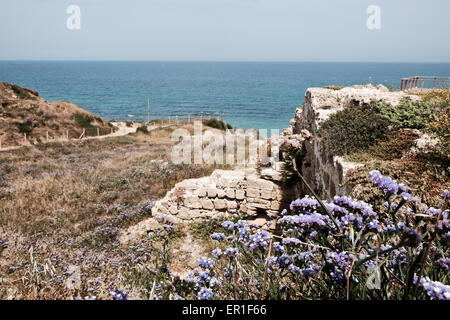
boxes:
[152,168,296,221]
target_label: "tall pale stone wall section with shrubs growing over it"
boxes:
[285,85,419,200]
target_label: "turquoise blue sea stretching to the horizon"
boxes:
[0,61,450,129]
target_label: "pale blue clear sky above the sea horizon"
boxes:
[0,0,450,62]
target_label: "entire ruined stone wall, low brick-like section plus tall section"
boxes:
[127,85,419,232]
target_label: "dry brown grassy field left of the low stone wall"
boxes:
[0,127,225,299]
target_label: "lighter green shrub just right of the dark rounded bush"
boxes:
[375,97,435,130]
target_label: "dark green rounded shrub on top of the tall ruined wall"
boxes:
[319,105,391,156]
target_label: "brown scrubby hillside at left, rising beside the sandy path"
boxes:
[0,82,113,147]
